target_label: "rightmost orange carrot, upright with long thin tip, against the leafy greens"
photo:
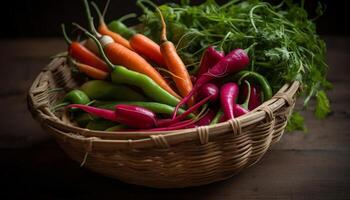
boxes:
[157,8,193,102]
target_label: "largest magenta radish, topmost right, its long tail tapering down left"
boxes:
[173,49,249,118]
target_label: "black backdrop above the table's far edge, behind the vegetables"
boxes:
[0,0,350,38]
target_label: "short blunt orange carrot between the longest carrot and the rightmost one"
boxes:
[129,33,166,67]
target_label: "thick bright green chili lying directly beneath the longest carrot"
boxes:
[111,66,180,106]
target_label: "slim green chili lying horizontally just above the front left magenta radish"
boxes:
[94,101,195,118]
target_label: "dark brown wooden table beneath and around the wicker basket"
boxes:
[0,37,350,199]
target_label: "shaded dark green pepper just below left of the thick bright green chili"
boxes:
[80,80,146,101]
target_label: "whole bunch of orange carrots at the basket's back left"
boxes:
[62,0,193,100]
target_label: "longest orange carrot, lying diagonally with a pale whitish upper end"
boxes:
[100,36,180,98]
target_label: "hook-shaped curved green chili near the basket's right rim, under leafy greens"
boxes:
[233,70,272,101]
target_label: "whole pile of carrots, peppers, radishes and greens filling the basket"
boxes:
[53,0,330,131]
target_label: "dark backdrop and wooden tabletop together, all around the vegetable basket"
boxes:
[0,0,350,200]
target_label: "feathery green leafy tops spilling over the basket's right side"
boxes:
[138,0,330,131]
